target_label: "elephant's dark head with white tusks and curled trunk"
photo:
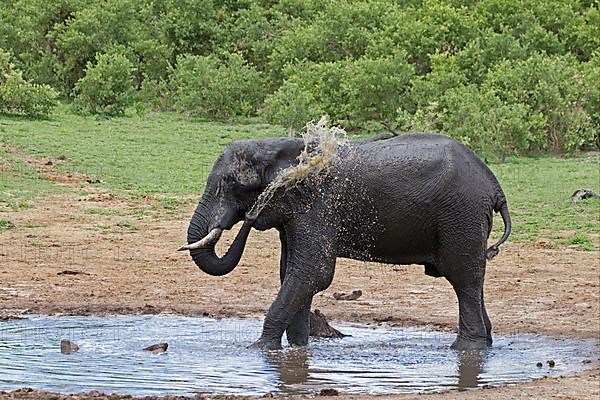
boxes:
[180,139,303,275]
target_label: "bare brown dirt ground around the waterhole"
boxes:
[0,180,600,400]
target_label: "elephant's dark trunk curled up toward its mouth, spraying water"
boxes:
[184,199,253,276]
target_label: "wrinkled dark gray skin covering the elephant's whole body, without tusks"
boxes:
[183,133,510,349]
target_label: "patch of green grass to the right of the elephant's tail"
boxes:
[490,156,600,250]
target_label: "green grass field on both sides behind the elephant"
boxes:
[0,109,600,250]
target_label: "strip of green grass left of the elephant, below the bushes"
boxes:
[0,108,284,194]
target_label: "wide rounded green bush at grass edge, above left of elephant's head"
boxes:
[171,54,266,120]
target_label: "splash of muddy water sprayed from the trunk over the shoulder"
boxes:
[246,115,348,219]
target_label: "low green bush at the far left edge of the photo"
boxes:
[0,49,57,116]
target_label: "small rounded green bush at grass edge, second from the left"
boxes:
[74,53,135,115]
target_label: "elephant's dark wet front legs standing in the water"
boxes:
[252,228,335,350]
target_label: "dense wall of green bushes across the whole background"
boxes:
[0,0,600,155]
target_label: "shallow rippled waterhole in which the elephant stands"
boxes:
[0,315,598,395]
